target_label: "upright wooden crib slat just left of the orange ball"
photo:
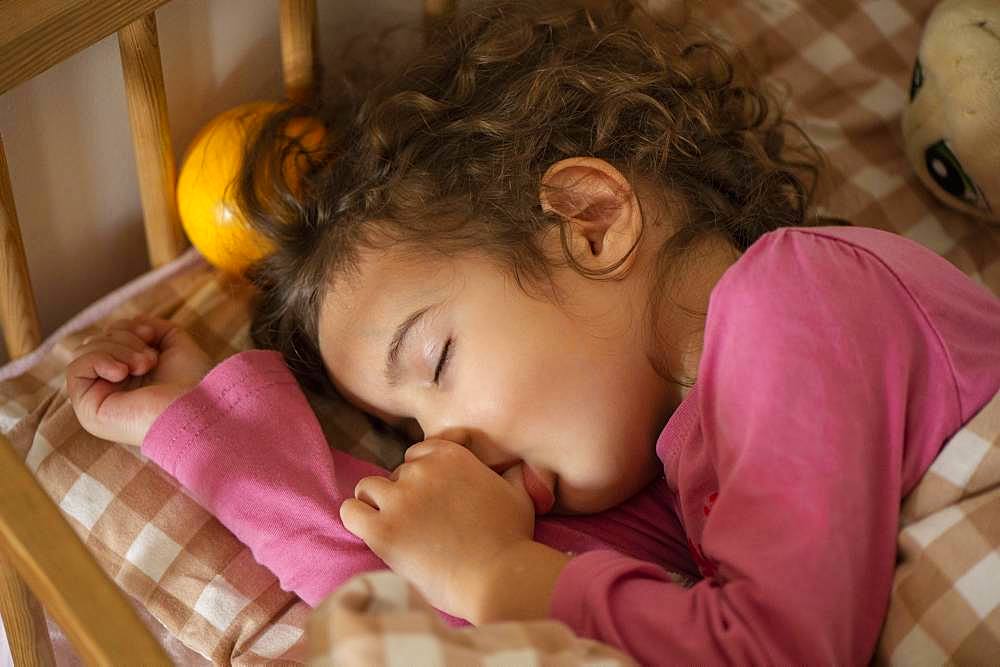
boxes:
[118,14,187,267]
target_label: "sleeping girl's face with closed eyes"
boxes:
[319,249,681,513]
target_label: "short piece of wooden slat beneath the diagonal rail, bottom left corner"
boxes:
[0,556,56,667]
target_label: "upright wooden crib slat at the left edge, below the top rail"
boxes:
[0,136,42,359]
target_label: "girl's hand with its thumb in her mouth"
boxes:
[340,440,535,620]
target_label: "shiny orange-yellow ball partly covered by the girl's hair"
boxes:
[177,102,322,274]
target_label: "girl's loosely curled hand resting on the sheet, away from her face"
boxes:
[66,317,213,446]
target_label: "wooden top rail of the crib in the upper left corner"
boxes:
[0,0,169,95]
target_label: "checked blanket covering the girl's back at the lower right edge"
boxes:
[876,393,1000,665]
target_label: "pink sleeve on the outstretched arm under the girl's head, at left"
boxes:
[142,350,388,606]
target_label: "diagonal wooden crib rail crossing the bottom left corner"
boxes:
[0,436,170,665]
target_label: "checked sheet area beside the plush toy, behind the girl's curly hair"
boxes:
[704,0,1000,294]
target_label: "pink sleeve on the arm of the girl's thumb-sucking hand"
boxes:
[552,228,984,664]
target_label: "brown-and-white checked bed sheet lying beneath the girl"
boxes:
[0,0,1000,664]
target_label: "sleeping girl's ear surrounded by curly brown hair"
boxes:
[538,157,642,278]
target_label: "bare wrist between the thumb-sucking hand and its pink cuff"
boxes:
[467,540,570,625]
